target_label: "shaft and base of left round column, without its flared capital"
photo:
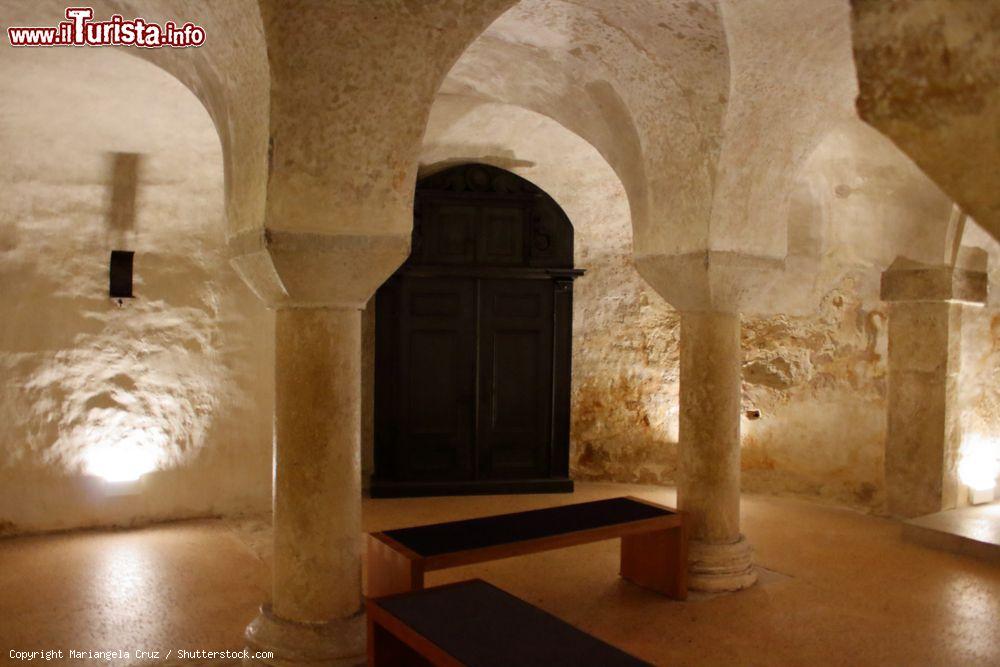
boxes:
[246,307,365,665]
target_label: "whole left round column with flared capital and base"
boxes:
[229,228,410,667]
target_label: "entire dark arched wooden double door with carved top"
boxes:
[371,164,583,497]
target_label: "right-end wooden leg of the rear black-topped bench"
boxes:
[621,525,688,600]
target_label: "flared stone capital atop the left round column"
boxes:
[229,227,410,309]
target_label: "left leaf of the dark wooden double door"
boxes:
[394,277,476,480]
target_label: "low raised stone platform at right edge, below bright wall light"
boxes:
[903,501,1000,565]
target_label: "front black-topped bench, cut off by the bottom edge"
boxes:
[367,579,650,667]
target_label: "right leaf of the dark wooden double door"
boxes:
[477,280,553,479]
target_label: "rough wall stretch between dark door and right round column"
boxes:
[564,213,680,483]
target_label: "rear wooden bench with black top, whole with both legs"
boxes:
[367,497,688,600]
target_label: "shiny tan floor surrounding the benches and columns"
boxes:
[0,484,1000,666]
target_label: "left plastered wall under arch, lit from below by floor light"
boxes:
[0,49,273,533]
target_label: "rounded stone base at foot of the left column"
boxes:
[244,604,366,667]
